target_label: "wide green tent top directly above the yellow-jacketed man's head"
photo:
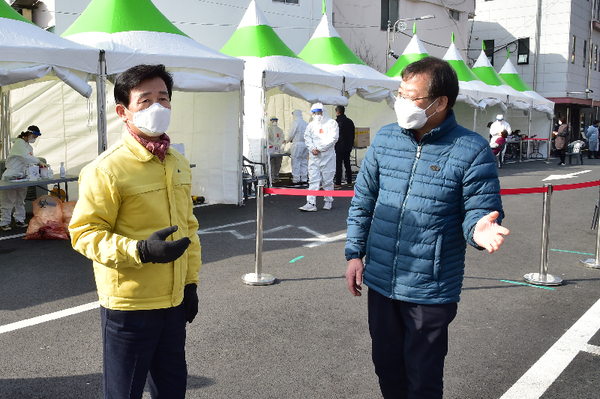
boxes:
[62,0,187,37]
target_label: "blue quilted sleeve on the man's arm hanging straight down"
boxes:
[345,146,379,260]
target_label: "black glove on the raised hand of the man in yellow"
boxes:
[137,226,191,263]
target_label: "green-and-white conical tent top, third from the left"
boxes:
[221,0,298,58]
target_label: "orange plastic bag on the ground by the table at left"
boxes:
[25,195,69,240]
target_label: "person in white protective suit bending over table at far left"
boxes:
[0,125,46,231]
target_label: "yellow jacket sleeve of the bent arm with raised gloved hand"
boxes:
[69,167,142,268]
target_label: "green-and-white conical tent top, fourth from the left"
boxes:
[298,12,366,65]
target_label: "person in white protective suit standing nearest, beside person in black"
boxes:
[299,103,339,212]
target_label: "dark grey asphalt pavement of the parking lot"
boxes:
[0,159,600,399]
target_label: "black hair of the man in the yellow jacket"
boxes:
[114,64,173,108]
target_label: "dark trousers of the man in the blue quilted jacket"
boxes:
[368,290,457,399]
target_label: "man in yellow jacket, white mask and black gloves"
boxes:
[69,65,202,398]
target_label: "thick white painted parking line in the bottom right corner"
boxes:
[500,300,600,399]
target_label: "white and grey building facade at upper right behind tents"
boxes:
[469,0,600,139]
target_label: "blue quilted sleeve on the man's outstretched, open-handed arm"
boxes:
[461,146,504,250]
